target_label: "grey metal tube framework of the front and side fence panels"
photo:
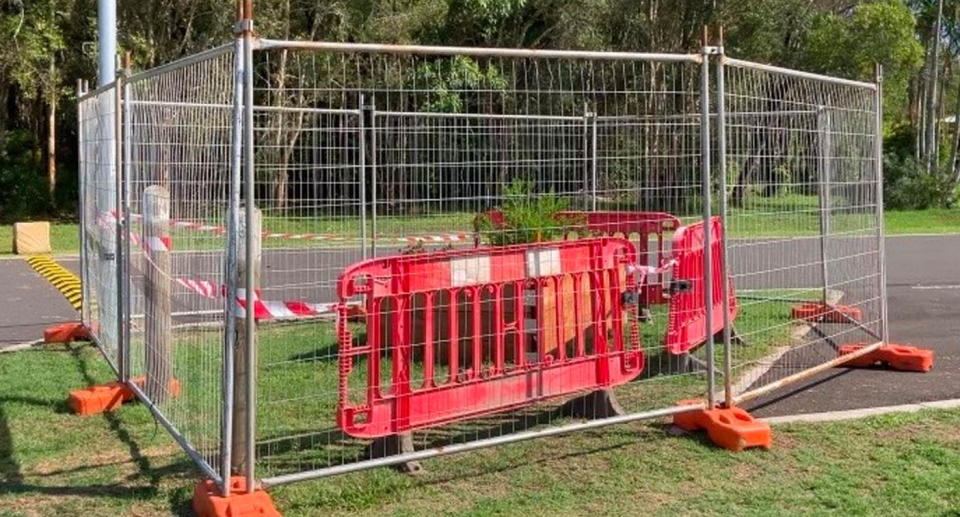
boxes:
[78,31,888,495]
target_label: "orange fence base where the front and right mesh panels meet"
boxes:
[673,400,773,452]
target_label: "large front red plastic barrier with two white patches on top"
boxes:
[337,237,644,438]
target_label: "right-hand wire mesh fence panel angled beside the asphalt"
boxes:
[719,60,885,400]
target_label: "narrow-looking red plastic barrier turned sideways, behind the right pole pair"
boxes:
[666,217,737,355]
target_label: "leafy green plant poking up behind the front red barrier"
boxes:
[473,178,578,246]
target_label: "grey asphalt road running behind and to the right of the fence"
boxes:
[0,235,960,416]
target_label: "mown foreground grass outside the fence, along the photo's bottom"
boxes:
[0,345,960,517]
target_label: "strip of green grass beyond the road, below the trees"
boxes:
[0,204,960,257]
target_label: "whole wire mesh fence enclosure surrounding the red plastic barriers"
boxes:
[80,36,885,491]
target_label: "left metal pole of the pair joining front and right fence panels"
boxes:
[700,39,716,408]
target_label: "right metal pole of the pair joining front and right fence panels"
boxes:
[717,47,733,407]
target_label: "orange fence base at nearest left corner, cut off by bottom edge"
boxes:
[193,476,281,517]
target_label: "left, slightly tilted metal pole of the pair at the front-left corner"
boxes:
[220,25,245,497]
